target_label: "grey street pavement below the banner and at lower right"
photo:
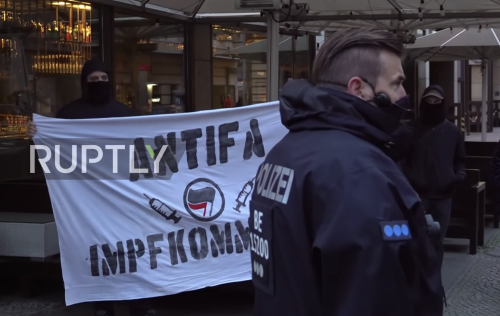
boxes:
[0,228,500,316]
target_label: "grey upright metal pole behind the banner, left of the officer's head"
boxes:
[266,10,280,102]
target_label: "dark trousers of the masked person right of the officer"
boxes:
[421,198,451,266]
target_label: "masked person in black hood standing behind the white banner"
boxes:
[28,59,156,316]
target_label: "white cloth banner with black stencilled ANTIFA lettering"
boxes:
[32,102,287,305]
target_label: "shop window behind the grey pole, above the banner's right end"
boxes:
[212,23,309,109]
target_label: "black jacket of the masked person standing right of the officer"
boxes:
[404,86,466,198]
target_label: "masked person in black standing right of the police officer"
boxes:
[405,85,465,270]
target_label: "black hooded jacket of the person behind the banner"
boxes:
[56,59,133,119]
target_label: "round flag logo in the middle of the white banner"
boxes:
[184,178,225,222]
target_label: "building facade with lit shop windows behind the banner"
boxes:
[0,0,316,186]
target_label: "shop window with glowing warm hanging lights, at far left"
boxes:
[0,0,98,137]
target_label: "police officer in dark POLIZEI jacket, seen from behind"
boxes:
[249,29,444,316]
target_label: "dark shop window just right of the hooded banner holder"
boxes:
[115,12,185,114]
